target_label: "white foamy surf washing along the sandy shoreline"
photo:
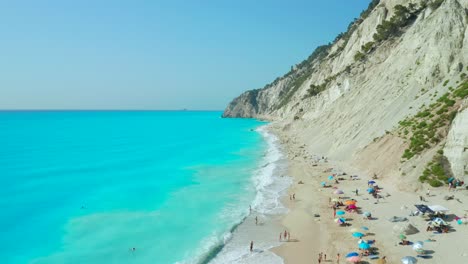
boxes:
[210,126,291,264]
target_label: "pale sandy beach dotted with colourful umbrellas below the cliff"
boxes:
[266,126,468,263]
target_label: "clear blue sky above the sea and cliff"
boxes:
[0,0,369,110]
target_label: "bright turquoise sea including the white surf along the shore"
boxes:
[0,111,288,264]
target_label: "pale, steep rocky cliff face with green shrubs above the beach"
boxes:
[223,0,468,182]
